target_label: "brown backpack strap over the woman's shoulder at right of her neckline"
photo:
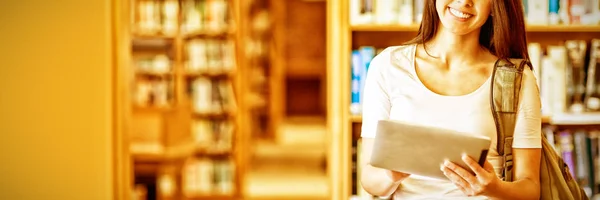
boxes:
[490,59,531,181]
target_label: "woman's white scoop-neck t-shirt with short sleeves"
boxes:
[361,45,541,199]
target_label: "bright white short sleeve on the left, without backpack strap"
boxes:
[361,49,391,138]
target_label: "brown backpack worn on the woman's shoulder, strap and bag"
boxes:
[490,59,588,200]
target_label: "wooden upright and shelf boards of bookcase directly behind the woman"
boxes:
[327,0,600,199]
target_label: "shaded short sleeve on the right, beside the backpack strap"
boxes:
[513,67,542,148]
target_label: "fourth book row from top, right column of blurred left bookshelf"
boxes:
[191,119,234,152]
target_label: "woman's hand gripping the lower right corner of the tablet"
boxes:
[441,156,502,196]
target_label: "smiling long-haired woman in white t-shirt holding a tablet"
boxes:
[361,0,541,199]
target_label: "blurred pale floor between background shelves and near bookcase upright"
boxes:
[244,117,328,200]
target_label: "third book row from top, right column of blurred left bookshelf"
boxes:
[190,77,236,115]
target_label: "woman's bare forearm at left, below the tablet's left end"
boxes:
[359,138,409,196]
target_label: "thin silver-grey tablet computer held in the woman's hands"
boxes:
[370,120,491,180]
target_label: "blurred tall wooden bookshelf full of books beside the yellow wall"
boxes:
[115,0,249,200]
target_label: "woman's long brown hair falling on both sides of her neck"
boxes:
[405,0,529,59]
